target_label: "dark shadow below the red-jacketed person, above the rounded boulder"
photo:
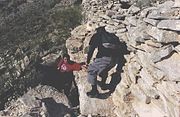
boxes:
[36,64,79,107]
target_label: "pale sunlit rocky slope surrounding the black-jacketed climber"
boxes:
[66,0,180,117]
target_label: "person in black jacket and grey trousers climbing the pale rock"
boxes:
[86,27,120,98]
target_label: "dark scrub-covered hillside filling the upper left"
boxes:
[0,0,82,109]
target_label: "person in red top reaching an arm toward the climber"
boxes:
[57,54,85,95]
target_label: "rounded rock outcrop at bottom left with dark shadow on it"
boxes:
[0,85,74,117]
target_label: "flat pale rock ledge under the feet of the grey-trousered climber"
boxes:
[74,73,114,117]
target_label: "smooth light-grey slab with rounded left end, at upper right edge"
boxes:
[157,20,180,31]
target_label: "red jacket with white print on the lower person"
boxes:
[57,59,82,72]
